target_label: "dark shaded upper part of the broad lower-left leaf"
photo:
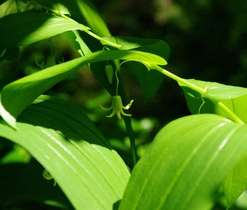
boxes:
[18,95,111,148]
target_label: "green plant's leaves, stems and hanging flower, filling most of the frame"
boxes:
[0,0,247,210]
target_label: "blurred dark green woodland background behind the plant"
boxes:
[0,0,247,209]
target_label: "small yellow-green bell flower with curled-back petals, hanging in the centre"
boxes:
[100,95,134,120]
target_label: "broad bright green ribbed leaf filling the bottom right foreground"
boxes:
[120,114,247,210]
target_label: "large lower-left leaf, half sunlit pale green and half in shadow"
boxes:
[0,98,129,209]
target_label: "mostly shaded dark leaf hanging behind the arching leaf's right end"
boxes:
[91,37,170,101]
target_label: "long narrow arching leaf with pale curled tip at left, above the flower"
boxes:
[0,50,166,127]
